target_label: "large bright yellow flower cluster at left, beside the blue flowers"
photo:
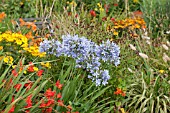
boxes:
[0,32,46,57]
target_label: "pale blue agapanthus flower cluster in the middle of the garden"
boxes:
[39,35,120,86]
